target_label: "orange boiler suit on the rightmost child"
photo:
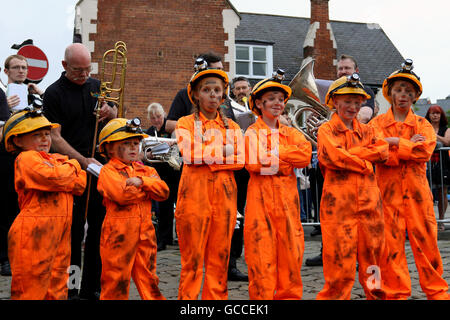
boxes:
[370,108,448,299]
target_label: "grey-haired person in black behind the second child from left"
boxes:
[146,103,181,251]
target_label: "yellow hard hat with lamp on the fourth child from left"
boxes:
[248,69,292,116]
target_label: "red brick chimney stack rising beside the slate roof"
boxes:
[303,0,337,80]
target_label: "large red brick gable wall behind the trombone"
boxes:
[89,0,230,128]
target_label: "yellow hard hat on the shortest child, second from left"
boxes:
[98,118,148,155]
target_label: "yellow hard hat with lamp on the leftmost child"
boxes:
[3,107,59,152]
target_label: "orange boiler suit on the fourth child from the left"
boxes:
[244,118,312,300]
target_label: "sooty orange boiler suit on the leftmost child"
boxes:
[8,151,86,300]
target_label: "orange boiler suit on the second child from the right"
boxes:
[316,113,389,300]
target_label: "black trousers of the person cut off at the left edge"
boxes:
[0,151,20,263]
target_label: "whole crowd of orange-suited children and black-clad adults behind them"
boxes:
[0,43,450,300]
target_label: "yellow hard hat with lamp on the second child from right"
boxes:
[325,73,371,109]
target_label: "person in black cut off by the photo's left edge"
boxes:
[0,89,19,276]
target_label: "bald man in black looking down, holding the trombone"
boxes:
[44,43,117,299]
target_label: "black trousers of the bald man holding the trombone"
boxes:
[70,177,106,298]
